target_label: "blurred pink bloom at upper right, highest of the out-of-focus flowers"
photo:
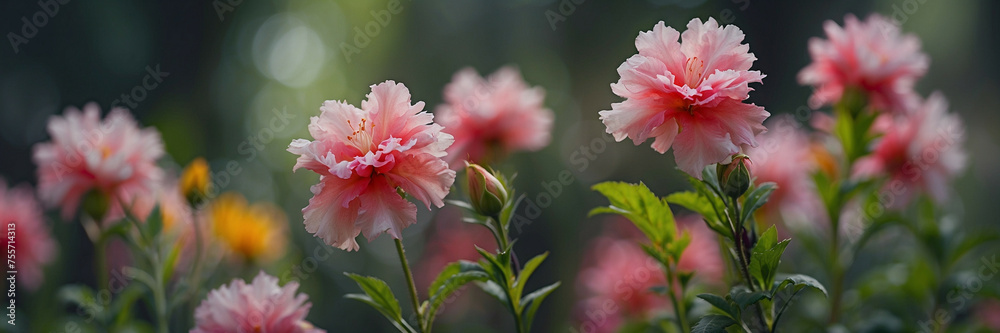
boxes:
[799,14,929,113]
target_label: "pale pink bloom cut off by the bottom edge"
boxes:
[191,272,325,333]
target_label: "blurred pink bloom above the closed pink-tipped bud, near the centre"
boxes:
[435,66,553,169]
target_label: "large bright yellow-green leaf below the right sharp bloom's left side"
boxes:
[589,182,677,245]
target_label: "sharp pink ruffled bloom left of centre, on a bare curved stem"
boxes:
[288,81,455,251]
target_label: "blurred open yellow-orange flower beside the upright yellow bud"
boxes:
[209,192,286,261]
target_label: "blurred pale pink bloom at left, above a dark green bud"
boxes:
[33,103,163,220]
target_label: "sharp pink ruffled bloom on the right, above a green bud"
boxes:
[600,18,770,178]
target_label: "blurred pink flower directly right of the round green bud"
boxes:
[747,115,826,227]
